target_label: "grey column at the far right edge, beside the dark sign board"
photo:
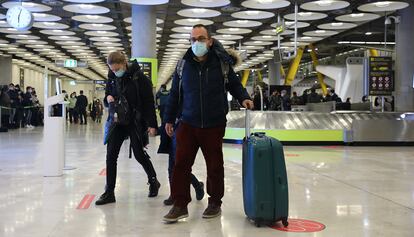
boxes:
[395,4,414,112]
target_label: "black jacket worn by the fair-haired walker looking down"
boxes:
[104,61,158,128]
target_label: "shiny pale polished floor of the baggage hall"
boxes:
[0,123,414,237]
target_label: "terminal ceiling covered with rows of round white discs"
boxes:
[0,0,410,82]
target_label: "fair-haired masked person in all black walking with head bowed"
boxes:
[95,51,161,205]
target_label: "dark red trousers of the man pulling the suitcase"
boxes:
[171,122,225,207]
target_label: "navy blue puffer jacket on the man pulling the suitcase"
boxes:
[164,41,250,128]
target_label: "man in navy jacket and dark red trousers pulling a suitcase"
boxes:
[164,25,253,222]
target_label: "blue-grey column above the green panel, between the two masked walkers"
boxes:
[131,5,157,58]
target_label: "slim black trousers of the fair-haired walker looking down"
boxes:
[106,123,157,191]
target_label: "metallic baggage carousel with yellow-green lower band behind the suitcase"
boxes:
[224,111,414,145]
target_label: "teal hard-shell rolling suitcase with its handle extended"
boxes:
[243,111,289,227]
